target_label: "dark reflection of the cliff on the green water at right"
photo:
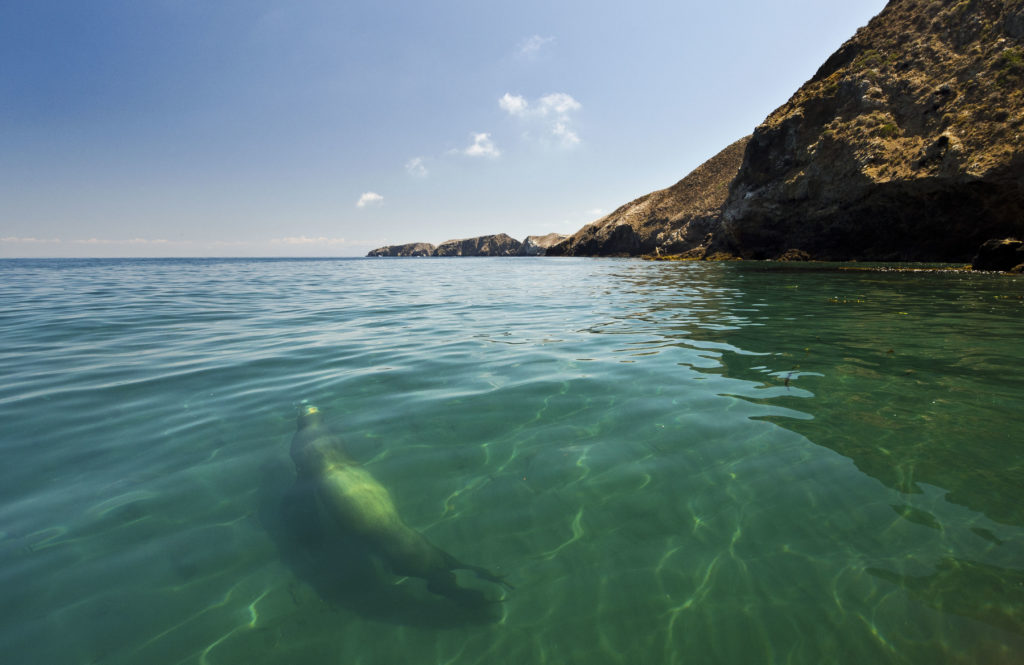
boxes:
[610,262,1024,526]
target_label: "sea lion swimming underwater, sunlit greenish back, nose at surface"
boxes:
[291,406,512,605]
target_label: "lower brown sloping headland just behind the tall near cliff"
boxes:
[548,136,750,256]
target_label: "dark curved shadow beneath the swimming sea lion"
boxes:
[251,462,502,629]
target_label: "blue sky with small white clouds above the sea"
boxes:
[0,0,885,257]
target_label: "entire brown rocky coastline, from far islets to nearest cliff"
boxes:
[370,0,1024,272]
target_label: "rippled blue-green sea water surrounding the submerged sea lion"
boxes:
[0,259,1024,664]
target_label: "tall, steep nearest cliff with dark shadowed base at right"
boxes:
[714,0,1024,262]
